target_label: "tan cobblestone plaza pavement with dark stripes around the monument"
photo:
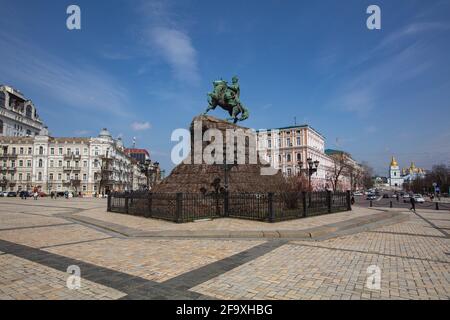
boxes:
[0,198,450,299]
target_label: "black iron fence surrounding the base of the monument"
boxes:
[108,191,351,223]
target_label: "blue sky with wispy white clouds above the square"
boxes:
[0,0,450,174]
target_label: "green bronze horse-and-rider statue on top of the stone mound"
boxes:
[204,77,249,123]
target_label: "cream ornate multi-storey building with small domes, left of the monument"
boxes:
[0,129,146,195]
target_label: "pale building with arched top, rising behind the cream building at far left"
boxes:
[0,85,44,137]
